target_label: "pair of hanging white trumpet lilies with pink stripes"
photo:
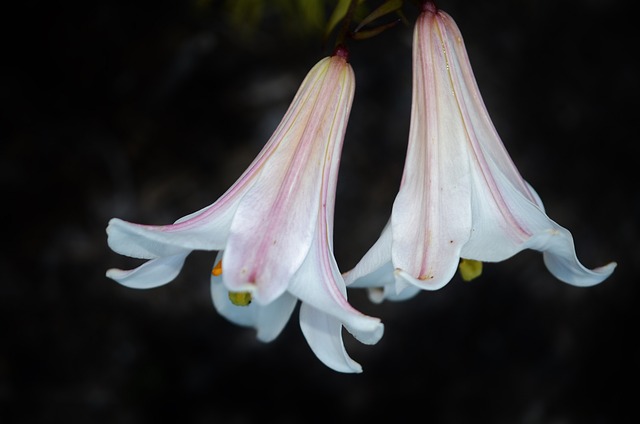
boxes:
[107,2,616,373]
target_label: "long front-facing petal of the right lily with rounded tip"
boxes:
[391,14,471,290]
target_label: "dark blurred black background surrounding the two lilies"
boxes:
[0,0,640,424]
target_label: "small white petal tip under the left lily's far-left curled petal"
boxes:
[107,249,191,289]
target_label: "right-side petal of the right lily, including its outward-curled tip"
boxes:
[434,11,616,286]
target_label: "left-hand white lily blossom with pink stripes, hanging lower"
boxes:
[107,48,383,372]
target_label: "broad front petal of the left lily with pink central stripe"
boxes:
[223,56,355,304]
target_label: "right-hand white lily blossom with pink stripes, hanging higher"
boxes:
[345,2,616,301]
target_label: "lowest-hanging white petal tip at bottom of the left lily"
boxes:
[300,303,362,373]
